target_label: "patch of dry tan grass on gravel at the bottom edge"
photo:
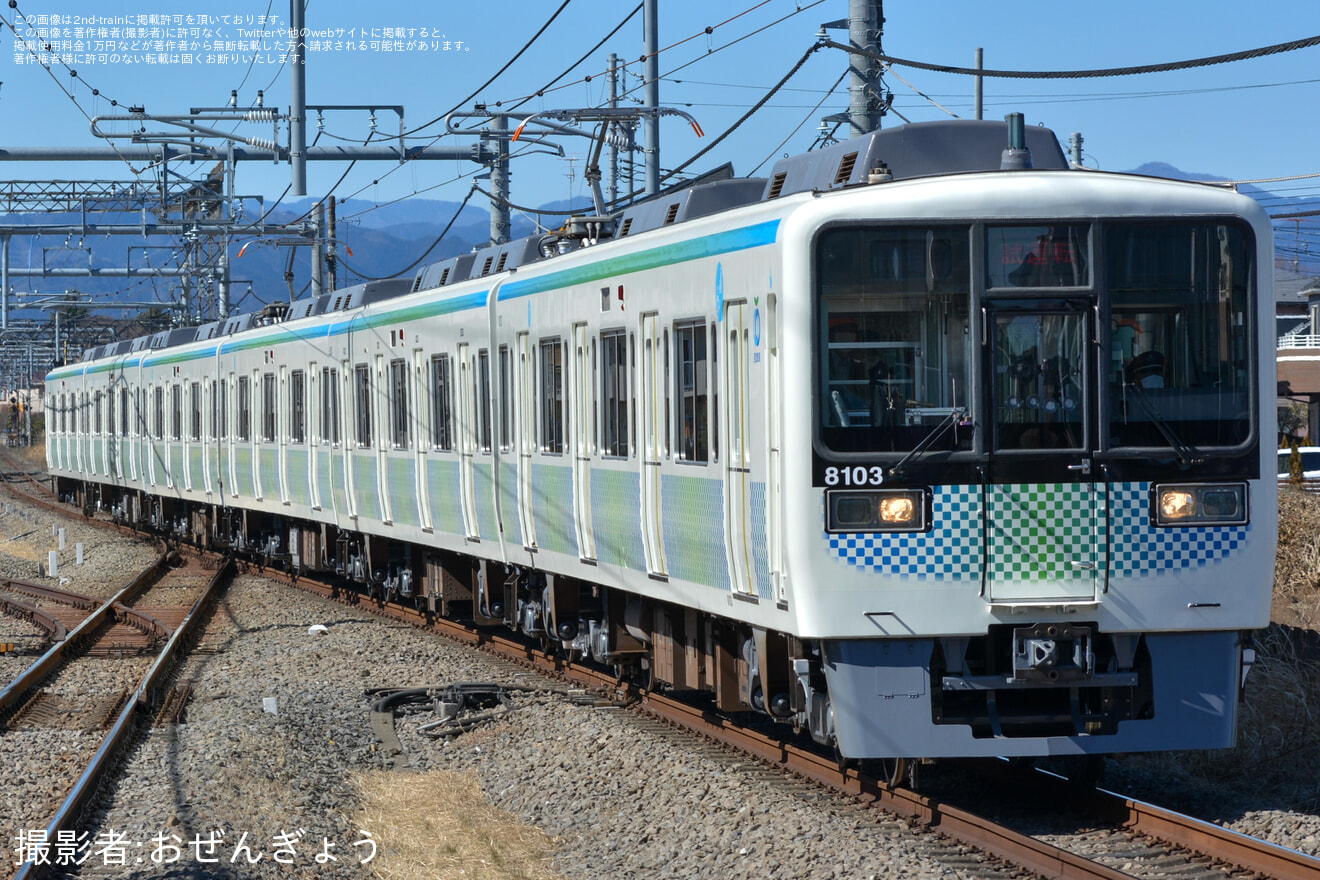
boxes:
[355,770,560,880]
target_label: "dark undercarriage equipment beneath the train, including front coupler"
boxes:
[58,480,1188,776]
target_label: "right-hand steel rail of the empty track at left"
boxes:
[13,563,232,880]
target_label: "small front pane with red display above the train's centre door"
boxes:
[986,223,1090,288]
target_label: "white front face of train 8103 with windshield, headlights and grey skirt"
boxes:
[771,124,1276,757]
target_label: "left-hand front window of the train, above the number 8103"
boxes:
[816,226,972,453]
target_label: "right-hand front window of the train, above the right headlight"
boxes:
[1105,222,1258,456]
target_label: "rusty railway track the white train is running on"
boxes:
[7,448,1320,880]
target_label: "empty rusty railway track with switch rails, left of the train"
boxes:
[0,543,231,879]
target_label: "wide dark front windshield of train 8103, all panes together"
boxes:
[814,219,1259,464]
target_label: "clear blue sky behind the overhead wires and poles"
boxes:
[0,0,1320,220]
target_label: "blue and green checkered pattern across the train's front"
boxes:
[821,483,1251,581]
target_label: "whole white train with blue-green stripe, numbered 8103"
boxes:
[48,121,1276,759]
